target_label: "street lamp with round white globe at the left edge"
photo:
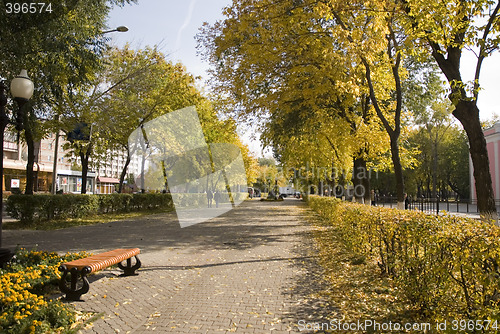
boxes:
[0,70,34,266]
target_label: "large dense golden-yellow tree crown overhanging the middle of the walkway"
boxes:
[199,0,390,201]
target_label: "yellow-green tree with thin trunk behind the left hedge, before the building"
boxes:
[102,45,201,192]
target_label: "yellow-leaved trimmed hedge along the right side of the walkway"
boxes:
[308,196,500,321]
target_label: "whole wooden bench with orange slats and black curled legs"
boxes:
[59,248,141,300]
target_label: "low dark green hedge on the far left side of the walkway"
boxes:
[6,194,173,224]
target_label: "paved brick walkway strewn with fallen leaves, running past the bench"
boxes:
[4,199,336,333]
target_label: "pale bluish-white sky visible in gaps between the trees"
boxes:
[108,0,500,156]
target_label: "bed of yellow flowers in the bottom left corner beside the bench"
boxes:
[0,249,88,334]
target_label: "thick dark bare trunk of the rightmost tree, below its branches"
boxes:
[453,100,498,222]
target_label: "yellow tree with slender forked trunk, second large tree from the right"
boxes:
[318,0,418,208]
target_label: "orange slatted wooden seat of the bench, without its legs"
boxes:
[63,248,140,272]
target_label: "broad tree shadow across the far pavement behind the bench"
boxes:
[3,200,305,253]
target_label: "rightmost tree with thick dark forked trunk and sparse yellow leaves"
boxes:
[400,0,500,220]
